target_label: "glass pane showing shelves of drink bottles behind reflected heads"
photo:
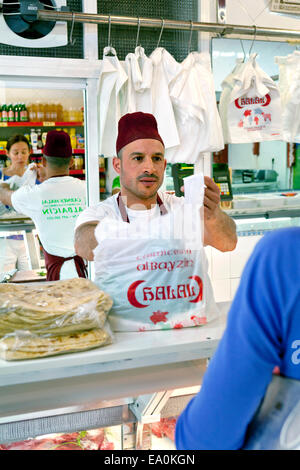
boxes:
[0,87,85,173]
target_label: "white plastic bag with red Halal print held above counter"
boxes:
[94,174,217,331]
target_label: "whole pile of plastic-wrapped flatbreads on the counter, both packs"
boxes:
[0,278,113,360]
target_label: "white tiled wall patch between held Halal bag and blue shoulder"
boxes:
[205,235,261,302]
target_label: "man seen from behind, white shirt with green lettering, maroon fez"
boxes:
[0,130,87,281]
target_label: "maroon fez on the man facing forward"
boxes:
[116,112,164,153]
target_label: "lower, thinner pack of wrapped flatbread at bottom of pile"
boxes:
[0,328,112,361]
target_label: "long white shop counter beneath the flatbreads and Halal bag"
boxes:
[0,302,230,443]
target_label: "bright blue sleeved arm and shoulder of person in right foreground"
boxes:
[175,227,300,450]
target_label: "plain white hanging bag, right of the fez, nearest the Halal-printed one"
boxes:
[166,52,224,164]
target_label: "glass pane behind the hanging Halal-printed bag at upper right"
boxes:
[212,38,300,196]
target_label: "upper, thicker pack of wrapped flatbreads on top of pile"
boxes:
[0,278,113,337]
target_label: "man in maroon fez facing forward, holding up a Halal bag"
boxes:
[75,112,237,261]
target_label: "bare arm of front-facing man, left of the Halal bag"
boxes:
[74,221,98,261]
